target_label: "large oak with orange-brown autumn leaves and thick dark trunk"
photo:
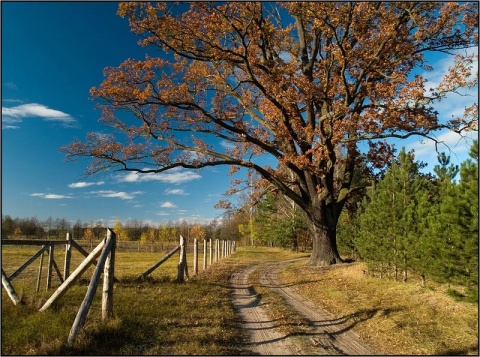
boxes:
[63,2,478,265]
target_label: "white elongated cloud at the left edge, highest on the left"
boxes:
[2,103,77,129]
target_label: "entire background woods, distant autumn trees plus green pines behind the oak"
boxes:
[2,141,478,296]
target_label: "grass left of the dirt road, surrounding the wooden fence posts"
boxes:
[1,246,304,355]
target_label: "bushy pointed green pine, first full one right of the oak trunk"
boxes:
[356,149,422,281]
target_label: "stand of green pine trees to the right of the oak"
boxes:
[338,141,478,296]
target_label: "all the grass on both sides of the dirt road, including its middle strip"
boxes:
[1,246,478,355]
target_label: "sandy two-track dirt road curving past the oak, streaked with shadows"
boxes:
[230,262,375,355]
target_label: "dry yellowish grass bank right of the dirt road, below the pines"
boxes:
[283,261,478,355]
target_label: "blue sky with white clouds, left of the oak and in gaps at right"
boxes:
[1,2,478,226]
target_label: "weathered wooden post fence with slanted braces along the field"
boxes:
[2,228,236,345]
